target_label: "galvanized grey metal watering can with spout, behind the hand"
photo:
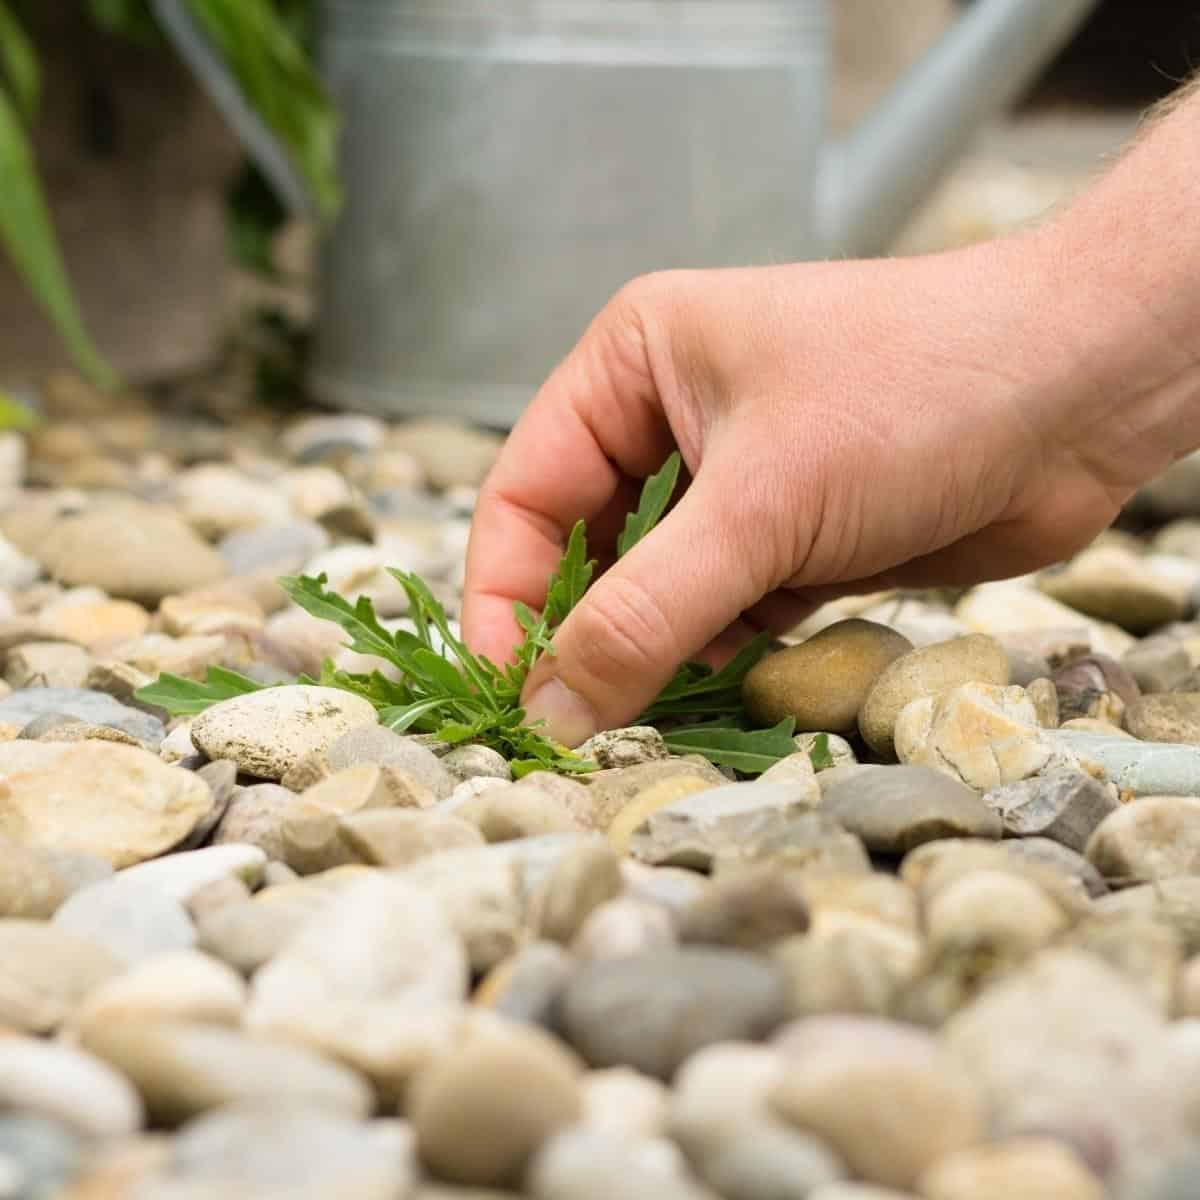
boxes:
[156,0,1096,426]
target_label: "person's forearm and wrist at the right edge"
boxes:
[1028,76,1200,487]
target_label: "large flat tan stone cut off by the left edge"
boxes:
[0,742,212,868]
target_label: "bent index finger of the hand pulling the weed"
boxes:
[463,278,674,661]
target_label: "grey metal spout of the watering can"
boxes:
[817,0,1096,257]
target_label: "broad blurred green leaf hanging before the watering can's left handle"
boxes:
[187,0,341,218]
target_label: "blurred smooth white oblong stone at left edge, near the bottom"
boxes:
[0,1037,142,1137]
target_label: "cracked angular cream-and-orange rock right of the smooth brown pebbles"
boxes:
[894,683,1069,792]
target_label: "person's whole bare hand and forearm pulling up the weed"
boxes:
[463,77,1200,745]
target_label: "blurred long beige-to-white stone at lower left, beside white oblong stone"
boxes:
[83,1021,372,1126]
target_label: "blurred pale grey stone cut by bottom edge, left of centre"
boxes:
[159,1103,418,1200]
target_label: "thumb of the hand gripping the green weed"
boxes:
[522,470,767,746]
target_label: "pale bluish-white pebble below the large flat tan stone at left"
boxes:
[54,875,196,966]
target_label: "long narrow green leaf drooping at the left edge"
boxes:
[0,90,116,388]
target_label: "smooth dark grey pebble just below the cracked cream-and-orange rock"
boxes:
[822,766,1002,854]
